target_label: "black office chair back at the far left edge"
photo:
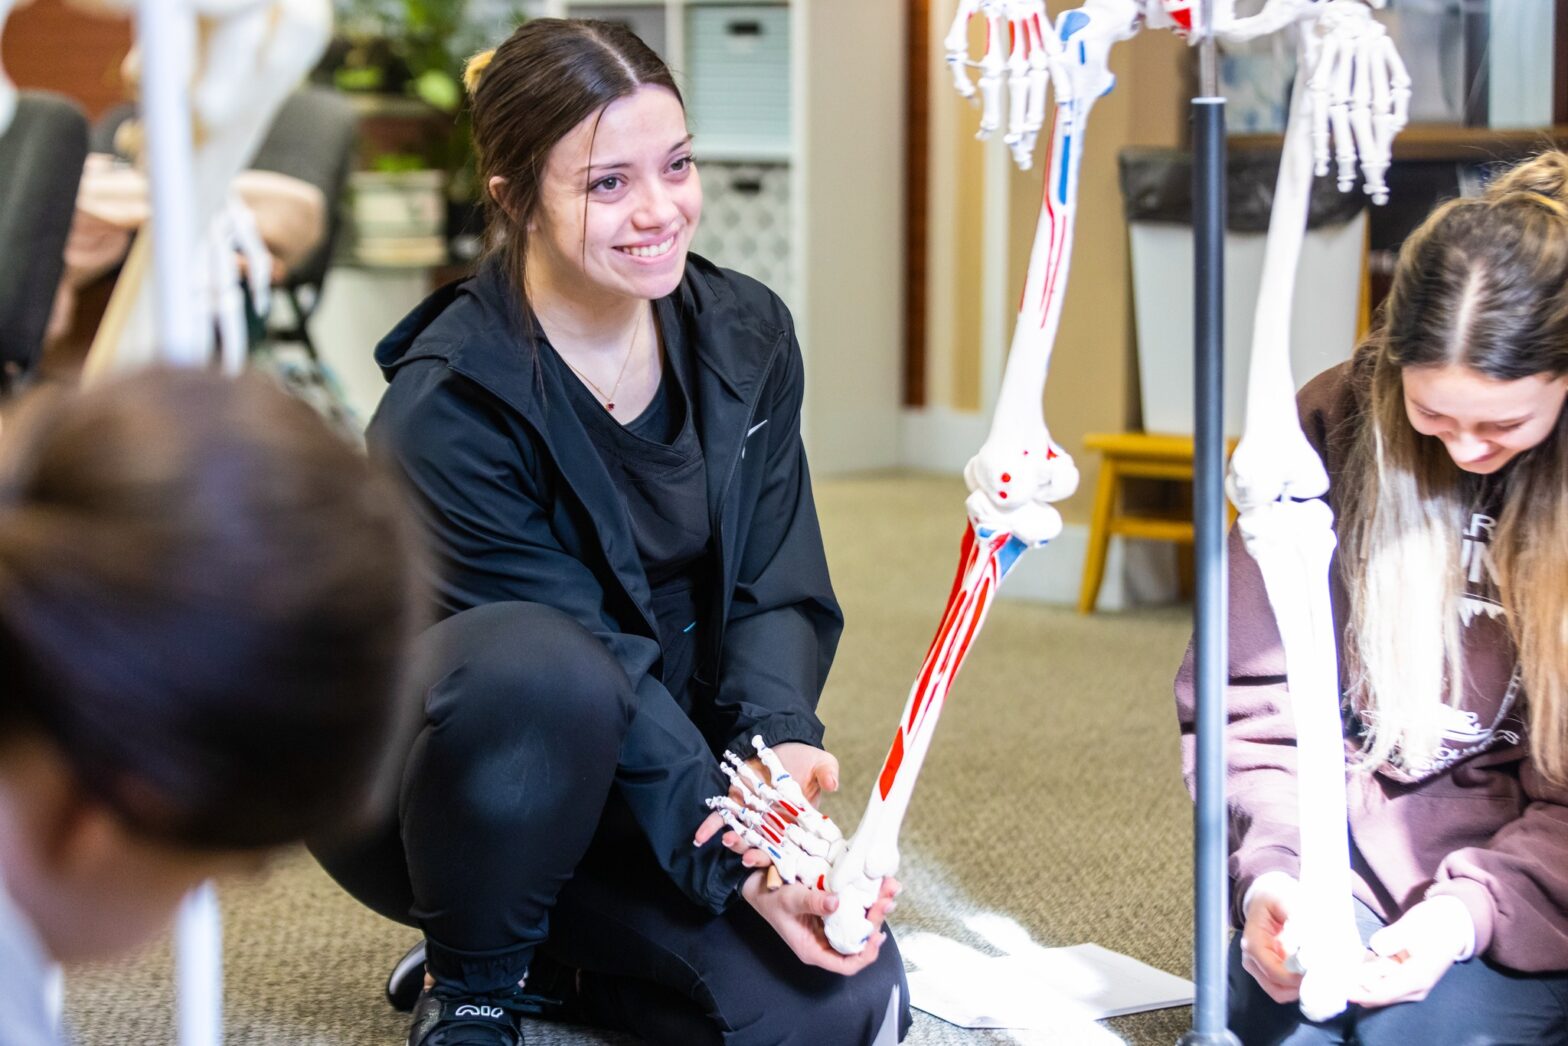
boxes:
[0,91,88,392]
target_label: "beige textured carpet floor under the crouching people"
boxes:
[58,475,1192,1046]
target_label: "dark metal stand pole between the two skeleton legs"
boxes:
[1181,2,1237,1046]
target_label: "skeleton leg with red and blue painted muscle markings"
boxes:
[717,0,1160,953]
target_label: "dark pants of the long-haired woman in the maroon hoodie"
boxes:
[1229,902,1568,1046]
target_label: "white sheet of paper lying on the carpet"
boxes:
[898,924,1193,1044]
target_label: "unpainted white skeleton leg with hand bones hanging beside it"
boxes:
[1228,0,1408,1019]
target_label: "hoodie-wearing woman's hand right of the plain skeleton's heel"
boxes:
[1350,895,1475,1007]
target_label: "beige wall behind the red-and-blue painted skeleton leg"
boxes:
[927,0,1189,522]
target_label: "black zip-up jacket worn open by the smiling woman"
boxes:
[368,256,844,911]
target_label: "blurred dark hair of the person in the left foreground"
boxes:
[0,370,423,848]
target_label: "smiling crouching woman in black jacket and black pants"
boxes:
[318,19,909,1046]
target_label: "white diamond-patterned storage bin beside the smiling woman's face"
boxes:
[691,163,793,301]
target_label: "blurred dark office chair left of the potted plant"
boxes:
[93,86,359,359]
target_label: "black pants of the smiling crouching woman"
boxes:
[317,602,909,1046]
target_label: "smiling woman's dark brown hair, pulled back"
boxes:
[464,19,684,307]
